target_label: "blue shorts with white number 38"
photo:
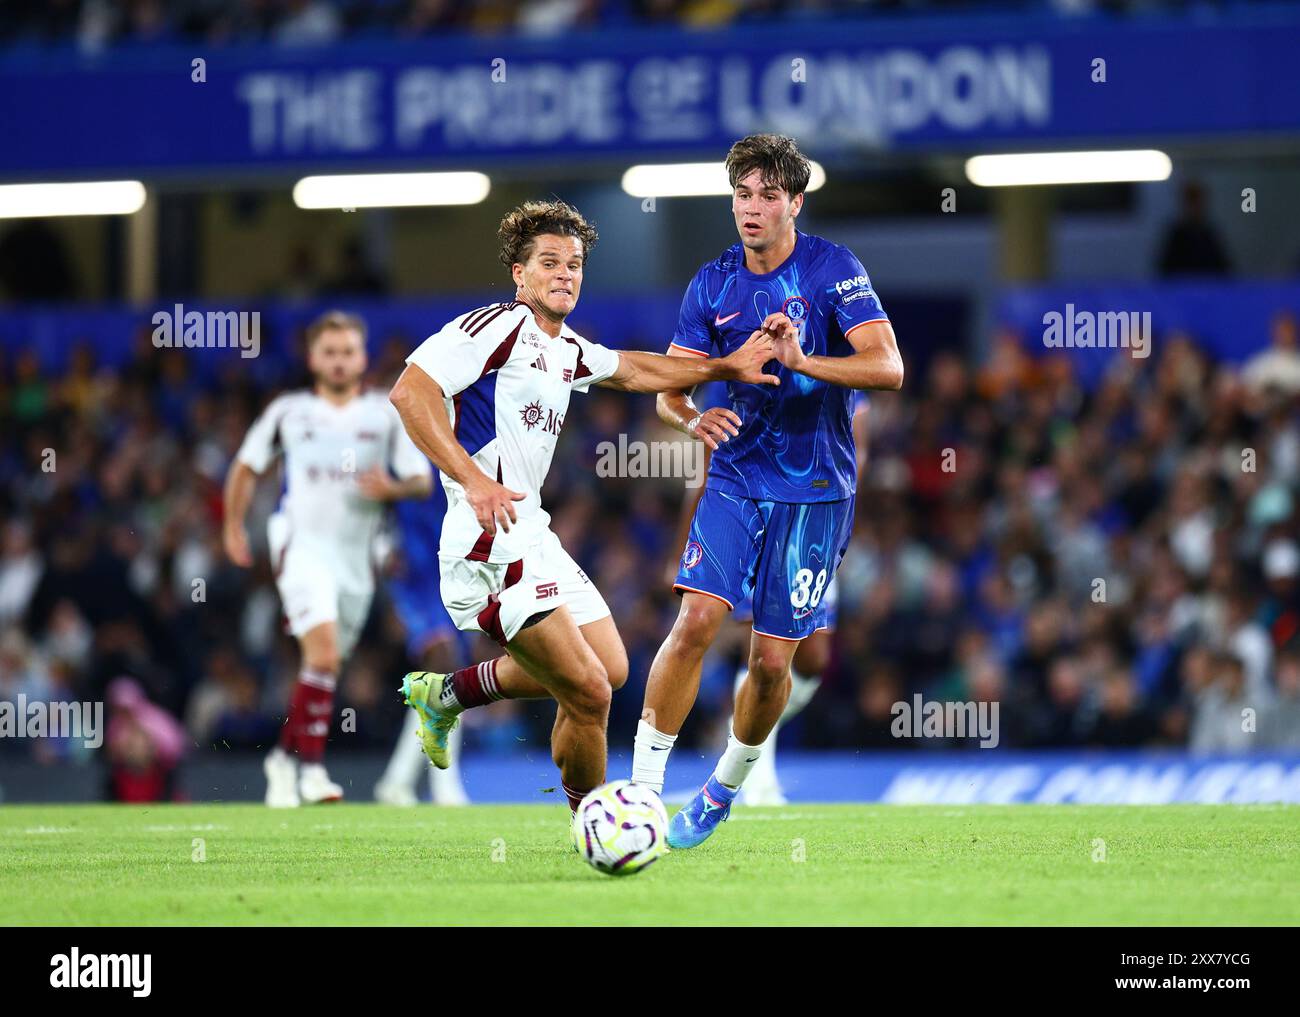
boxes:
[673,488,853,640]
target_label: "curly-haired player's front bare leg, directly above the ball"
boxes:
[507,607,627,809]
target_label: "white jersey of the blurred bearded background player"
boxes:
[235,390,432,585]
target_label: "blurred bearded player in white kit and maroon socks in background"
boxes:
[222,311,433,808]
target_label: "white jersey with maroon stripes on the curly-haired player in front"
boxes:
[407,302,619,564]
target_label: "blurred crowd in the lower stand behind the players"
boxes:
[0,303,1300,780]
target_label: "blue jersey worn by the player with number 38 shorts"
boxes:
[672,231,888,502]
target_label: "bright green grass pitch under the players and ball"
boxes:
[0,805,1300,925]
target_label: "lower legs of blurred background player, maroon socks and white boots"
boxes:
[263,622,343,808]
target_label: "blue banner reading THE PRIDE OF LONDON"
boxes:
[0,9,1300,179]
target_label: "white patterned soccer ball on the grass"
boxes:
[572,780,668,875]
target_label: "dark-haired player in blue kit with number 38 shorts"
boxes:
[632,134,904,848]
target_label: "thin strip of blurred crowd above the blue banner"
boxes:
[0,0,1248,51]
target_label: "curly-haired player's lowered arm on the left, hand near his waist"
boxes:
[389,364,528,536]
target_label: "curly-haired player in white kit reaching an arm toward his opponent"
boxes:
[391,202,789,809]
